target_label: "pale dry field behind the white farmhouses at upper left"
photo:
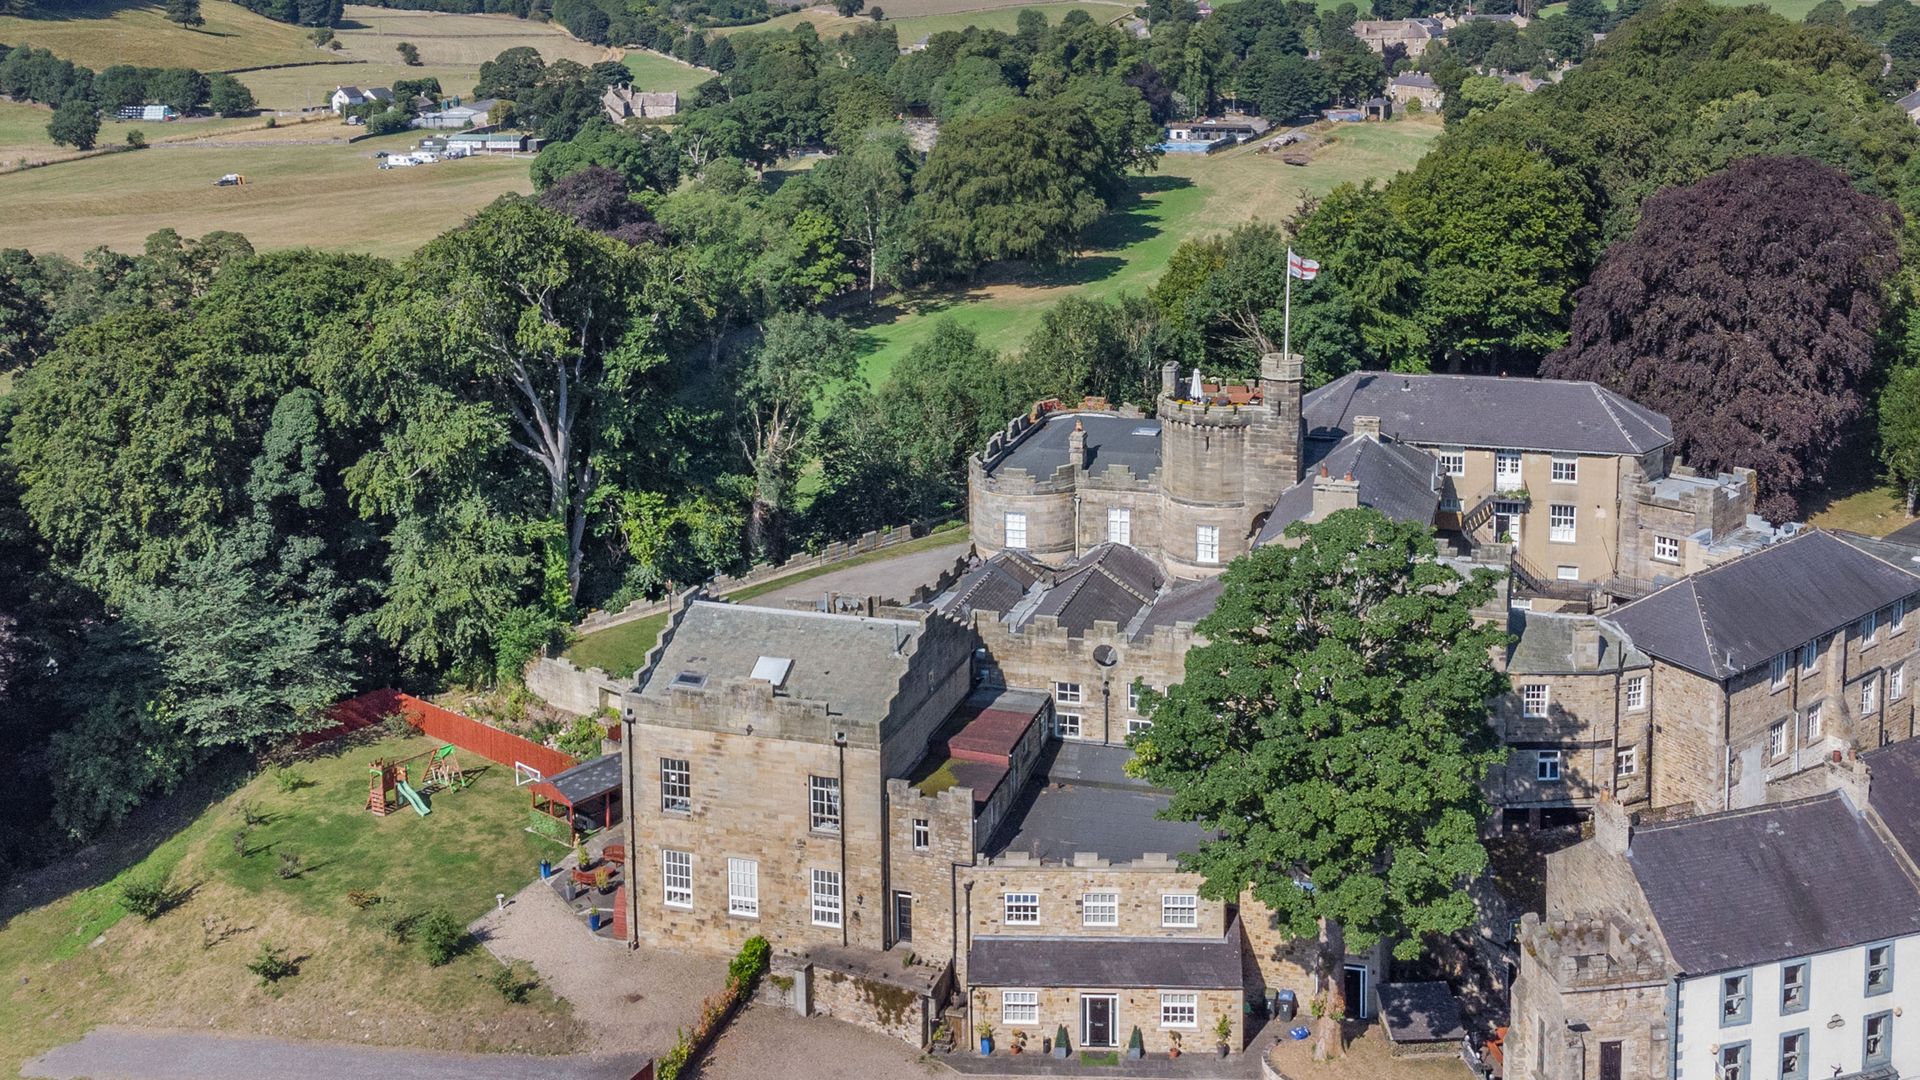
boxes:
[240,4,618,110]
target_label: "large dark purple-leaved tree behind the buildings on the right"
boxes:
[1542,158,1901,519]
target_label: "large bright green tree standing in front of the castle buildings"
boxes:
[1131,509,1507,1055]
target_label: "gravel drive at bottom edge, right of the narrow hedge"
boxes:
[701,1001,952,1080]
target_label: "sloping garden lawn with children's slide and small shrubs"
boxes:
[0,726,586,1074]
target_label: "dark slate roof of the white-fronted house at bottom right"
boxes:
[1626,792,1920,974]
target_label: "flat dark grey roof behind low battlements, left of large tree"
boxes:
[981,737,1208,861]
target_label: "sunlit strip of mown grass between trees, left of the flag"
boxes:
[860,117,1440,384]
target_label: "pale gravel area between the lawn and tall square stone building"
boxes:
[472,882,726,1055]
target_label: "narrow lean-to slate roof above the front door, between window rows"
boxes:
[966,907,1240,990]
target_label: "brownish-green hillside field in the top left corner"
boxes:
[0,0,326,71]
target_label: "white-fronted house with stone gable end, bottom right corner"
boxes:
[1505,742,1920,1080]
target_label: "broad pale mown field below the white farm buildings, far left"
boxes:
[0,123,532,258]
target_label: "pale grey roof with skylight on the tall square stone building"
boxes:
[641,600,925,723]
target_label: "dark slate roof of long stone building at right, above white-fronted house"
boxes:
[1613,528,1920,680]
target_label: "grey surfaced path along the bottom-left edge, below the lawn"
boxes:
[21,1028,645,1080]
